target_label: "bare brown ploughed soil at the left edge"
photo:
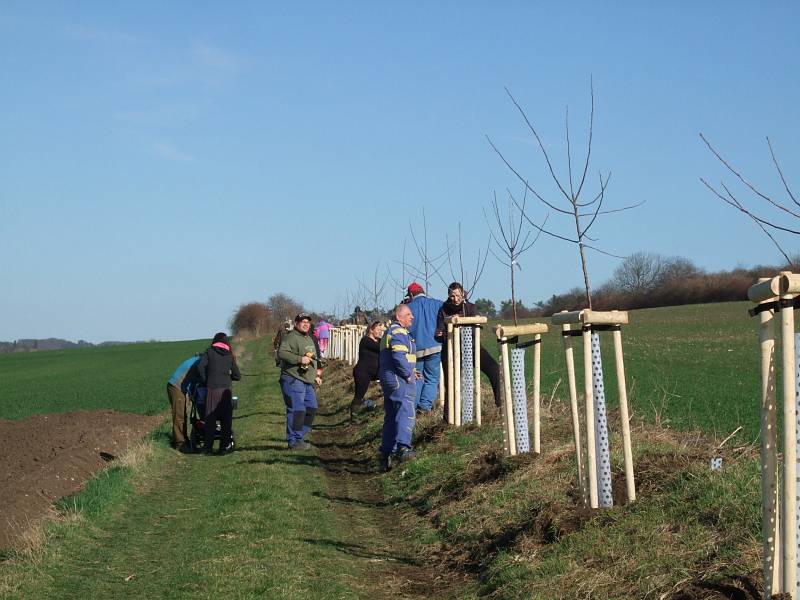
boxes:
[0,410,163,548]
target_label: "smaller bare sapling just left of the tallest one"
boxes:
[483,186,547,325]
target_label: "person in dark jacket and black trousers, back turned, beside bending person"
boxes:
[197,332,242,454]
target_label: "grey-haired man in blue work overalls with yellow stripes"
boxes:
[378,304,419,471]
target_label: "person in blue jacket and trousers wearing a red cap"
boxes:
[407,281,442,413]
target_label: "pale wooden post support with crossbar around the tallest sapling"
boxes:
[552,309,636,508]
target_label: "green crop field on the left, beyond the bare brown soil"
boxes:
[0,340,209,419]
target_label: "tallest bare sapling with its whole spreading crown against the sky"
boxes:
[486,84,643,309]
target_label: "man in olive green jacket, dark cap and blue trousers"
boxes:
[278,312,322,450]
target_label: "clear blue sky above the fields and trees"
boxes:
[0,1,800,342]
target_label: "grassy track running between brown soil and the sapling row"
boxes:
[0,342,472,598]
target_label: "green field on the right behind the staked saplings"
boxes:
[484,302,761,441]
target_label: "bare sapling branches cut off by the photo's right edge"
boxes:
[700,132,800,267]
